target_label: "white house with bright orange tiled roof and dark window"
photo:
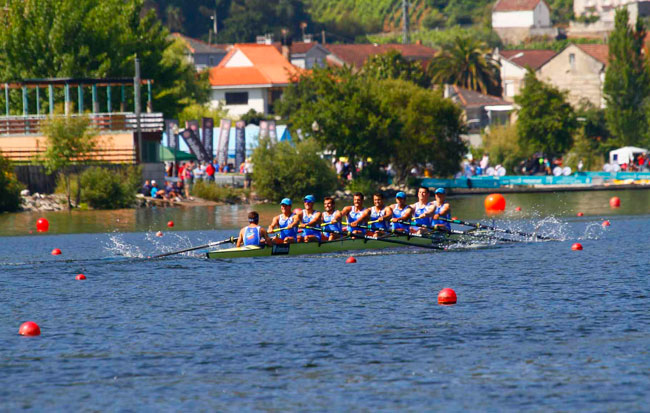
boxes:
[210,44,300,116]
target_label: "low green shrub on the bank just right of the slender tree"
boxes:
[81,167,141,209]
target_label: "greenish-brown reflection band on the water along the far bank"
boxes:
[0,190,650,238]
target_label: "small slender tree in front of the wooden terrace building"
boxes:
[36,116,99,209]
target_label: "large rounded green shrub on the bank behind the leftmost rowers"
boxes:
[252,138,336,201]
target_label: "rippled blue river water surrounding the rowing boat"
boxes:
[0,190,650,411]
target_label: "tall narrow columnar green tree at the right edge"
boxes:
[603,7,650,146]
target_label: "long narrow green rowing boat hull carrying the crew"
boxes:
[206,230,484,259]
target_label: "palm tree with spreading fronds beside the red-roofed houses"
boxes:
[428,35,501,96]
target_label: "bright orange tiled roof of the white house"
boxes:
[210,44,300,86]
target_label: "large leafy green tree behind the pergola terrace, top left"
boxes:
[0,0,207,116]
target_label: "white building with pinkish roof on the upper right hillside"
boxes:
[492,0,557,44]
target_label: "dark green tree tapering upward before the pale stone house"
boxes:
[515,69,577,155]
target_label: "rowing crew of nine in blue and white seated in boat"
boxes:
[237,187,451,247]
